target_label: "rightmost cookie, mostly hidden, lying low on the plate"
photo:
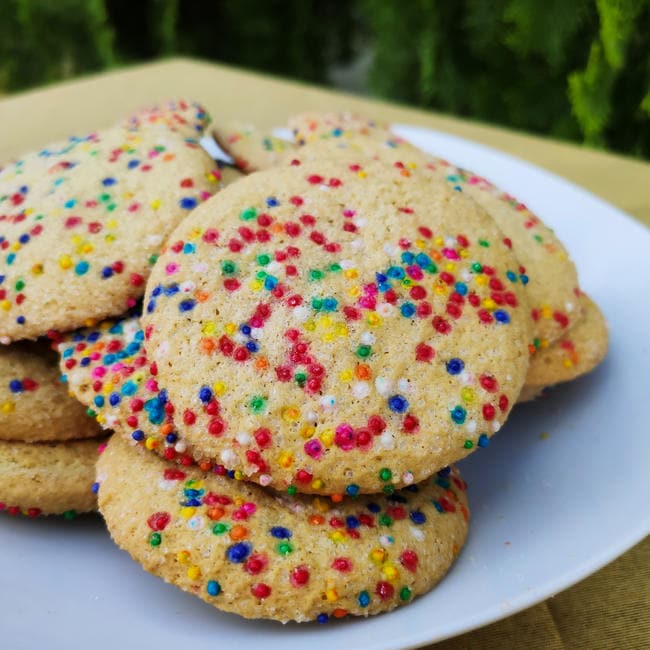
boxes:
[519,293,609,394]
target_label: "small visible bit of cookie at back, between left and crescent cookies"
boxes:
[212,122,294,173]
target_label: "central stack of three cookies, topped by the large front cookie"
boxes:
[59,128,531,622]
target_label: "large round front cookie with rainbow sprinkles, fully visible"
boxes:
[142,161,530,495]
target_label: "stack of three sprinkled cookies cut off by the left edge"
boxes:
[0,102,225,516]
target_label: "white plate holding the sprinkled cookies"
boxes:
[0,126,650,650]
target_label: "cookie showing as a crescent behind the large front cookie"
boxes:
[290,114,580,344]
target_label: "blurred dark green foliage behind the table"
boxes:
[0,0,650,158]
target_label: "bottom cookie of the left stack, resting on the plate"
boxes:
[0,438,103,517]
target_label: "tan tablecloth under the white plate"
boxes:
[0,59,650,650]
